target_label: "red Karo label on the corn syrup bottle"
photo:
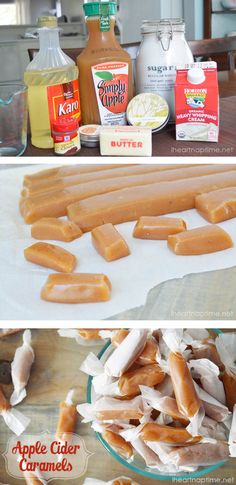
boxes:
[47,79,81,130]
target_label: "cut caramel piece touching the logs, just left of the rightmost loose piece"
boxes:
[133,216,186,240]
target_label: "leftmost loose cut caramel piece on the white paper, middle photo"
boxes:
[24,242,76,273]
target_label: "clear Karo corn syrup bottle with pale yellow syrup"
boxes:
[24,17,81,148]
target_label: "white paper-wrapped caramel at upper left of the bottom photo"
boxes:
[10,330,34,406]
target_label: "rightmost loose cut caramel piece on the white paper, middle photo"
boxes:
[168,224,233,256]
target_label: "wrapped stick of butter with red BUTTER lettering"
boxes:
[100,126,152,157]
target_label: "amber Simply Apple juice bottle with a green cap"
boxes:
[77,0,133,125]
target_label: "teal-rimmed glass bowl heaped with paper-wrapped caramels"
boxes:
[77,329,236,480]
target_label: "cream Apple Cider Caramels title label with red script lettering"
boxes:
[3,431,92,483]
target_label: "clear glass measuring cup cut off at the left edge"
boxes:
[0,82,27,157]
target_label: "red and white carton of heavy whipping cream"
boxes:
[175,62,219,142]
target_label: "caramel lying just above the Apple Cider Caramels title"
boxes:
[56,402,78,441]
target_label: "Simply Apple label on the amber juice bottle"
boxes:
[92,62,129,125]
